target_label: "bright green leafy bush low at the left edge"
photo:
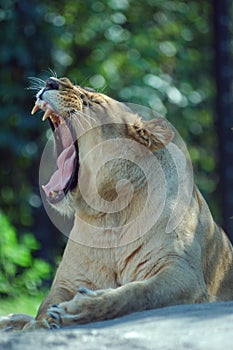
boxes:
[0,212,51,296]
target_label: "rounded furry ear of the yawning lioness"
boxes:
[127,118,174,152]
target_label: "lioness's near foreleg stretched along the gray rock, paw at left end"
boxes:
[47,266,208,326]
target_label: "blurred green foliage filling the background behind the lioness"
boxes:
[0,0,226,300]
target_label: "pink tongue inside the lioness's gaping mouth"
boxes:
[42,144,75,196]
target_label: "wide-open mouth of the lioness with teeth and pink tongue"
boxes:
[31,99,78,203]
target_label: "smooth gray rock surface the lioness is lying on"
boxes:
[0,301,233,350]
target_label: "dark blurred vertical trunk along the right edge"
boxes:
[214,0,233,242]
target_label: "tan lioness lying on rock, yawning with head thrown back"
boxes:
[0,77,233,330]
